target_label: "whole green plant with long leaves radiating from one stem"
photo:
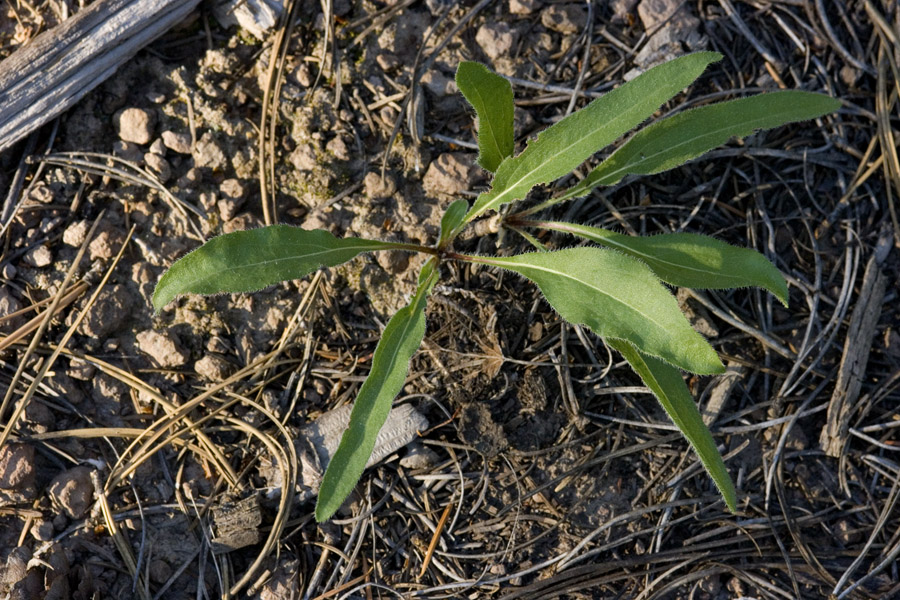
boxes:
[153,52,840,521]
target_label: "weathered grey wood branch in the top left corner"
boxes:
[0,0,199,152]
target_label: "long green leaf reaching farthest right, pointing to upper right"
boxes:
[559,91,841,202]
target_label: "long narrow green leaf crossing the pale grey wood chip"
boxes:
[316,258,437,523]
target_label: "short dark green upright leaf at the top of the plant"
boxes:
[456,62,515,173]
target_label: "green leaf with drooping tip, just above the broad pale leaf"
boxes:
[541,221,788,306]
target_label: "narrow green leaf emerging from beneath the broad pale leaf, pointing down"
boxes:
[606,339,737,513]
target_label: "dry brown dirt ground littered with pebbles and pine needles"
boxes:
[0,0,900,600]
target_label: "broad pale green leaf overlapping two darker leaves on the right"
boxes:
[479,248,724,374]
